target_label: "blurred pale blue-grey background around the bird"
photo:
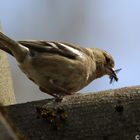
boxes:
[0,0,140,103]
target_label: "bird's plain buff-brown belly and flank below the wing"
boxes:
[20,56,93,92]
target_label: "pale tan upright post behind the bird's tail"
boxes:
[0,24,16,105]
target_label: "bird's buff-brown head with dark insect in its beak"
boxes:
[93,48,120,83]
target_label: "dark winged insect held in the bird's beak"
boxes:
[109,68,122,84]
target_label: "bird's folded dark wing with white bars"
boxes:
[18,41,84,59]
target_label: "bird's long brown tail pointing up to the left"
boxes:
[0,32,28,62]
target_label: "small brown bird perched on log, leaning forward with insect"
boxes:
[0,32,118,99]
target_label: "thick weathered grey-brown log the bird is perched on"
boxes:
[2,86,140,140]
